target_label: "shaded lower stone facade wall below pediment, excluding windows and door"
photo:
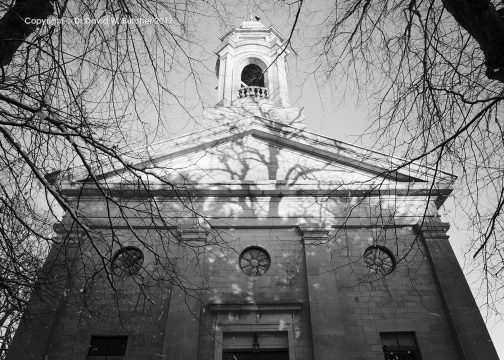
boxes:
[9,197,496,360]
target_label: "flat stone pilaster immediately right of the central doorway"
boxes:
[299,224,346,360]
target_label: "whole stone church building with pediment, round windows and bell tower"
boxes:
[8,19,498,360]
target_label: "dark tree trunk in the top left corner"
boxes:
[0,0,53,67]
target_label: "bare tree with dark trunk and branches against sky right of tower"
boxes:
[312,0,504,312]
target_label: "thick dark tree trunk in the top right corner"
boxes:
[442,0,504,82]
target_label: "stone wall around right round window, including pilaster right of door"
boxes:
[306,227,459,360]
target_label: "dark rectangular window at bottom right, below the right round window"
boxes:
[380,332,421,360]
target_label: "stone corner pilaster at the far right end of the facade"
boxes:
[416,218,498,360]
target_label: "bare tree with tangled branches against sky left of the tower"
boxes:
[0,0,221,358]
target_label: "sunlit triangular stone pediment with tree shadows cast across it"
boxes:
[93,116,454,193]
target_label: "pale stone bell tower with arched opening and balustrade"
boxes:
[215,14,289,107]
